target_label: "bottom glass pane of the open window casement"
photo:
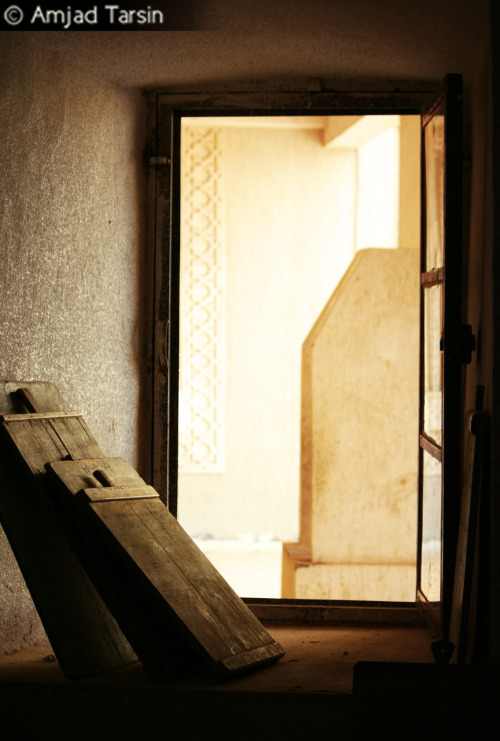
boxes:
[420,450,441,602]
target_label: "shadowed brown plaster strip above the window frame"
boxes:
[19,0,489,89]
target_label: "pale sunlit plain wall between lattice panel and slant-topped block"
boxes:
[179,121,356,540]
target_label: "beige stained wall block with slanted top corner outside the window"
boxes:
[282,249,419,601]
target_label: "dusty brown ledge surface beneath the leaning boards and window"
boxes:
[0,623,433,694]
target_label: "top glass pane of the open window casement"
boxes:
[425,116,444,270]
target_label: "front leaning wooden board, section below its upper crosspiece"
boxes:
[91,499,283,674]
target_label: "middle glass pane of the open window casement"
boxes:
[424,285,443,445]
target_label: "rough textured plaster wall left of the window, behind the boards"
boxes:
[0,36,144,651]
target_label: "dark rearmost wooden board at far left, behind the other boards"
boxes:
[0,382,137,679]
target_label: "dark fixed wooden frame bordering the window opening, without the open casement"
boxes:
[146,84,458,623]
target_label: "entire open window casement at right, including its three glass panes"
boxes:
[417,75,473,638]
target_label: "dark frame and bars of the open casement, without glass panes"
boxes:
[417,75,464,640]
